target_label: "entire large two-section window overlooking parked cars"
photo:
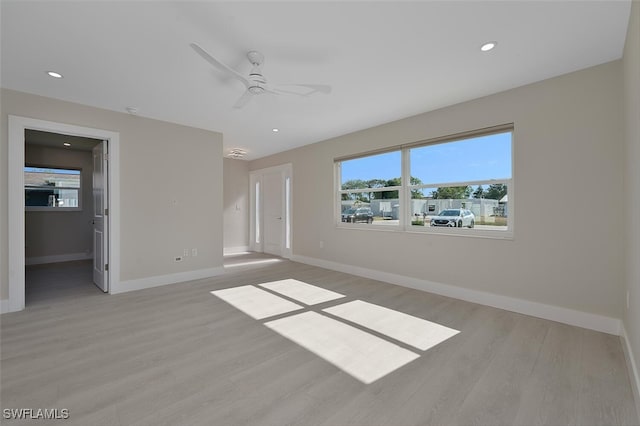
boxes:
[336,126,513,236]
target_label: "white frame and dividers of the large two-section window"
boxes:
[334,123,515,239]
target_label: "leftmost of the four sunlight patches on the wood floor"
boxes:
[211,285,302,319]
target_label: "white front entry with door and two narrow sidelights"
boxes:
[249,164,293,258]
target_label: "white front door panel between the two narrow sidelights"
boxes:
[262,171,284,256]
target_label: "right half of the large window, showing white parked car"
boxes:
[409,132,511,231]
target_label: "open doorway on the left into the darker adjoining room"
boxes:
[24,129,109,303]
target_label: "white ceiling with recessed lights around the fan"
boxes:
[0,0,630,159]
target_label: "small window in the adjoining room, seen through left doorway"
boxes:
[24,166,82,210]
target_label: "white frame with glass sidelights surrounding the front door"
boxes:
[249,163,293,259]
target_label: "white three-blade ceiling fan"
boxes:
[191,43,331,108]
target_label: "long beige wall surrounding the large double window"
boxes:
[250,61,625,318]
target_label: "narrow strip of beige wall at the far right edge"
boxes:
[621,1,640,415]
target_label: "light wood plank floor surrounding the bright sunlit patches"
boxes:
[0,255,639,426]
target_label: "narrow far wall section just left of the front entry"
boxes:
[224,158,249,253]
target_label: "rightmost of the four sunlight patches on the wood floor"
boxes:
[323,300,459,351]
